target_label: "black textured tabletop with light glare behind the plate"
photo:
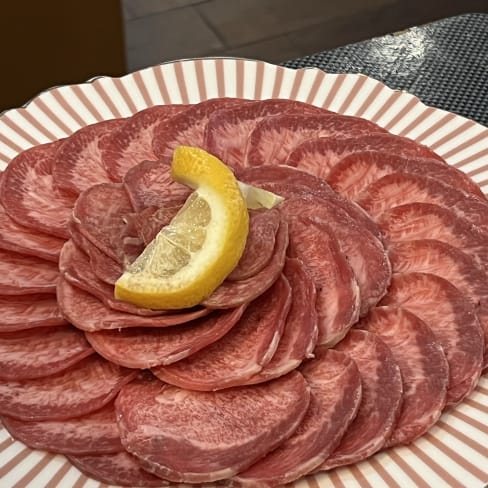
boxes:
[283,13,488,125]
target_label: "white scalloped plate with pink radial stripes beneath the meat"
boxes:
[0,59,488,488]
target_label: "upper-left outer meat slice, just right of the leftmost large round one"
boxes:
[53,119,124,195]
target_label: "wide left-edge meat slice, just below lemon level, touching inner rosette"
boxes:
[0,325,93,380]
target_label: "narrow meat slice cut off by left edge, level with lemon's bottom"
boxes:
[0,294,66,332]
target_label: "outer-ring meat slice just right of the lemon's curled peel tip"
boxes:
[204,99,327,168]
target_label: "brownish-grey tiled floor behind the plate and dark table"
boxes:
[122,0,488,71]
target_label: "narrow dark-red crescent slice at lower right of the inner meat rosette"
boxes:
[247,258,318,385]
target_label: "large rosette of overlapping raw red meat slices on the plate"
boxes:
[0,98,488,487]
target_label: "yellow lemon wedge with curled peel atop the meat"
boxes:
[115,146,249,309]
